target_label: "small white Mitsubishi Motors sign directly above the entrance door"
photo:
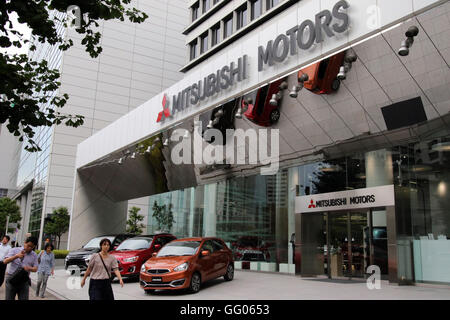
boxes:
[295,185,395,213]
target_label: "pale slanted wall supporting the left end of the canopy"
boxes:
[68,172,128,250]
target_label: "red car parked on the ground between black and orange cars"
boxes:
[111,233,176,277]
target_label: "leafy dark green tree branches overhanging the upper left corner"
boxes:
[0,0,148,152]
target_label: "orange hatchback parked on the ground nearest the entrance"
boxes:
[139,238,234,293]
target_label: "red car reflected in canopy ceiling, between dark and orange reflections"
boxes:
[241,78,287,127]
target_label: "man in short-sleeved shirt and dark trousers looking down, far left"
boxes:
[3,237,38,300]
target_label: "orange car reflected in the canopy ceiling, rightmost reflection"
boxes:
[298,51,345,94]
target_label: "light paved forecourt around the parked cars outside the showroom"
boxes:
[26,269,450,300]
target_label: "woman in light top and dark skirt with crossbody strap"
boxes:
[81,238,123,300]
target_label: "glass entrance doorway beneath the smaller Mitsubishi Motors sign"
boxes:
[301,209,388,278]
